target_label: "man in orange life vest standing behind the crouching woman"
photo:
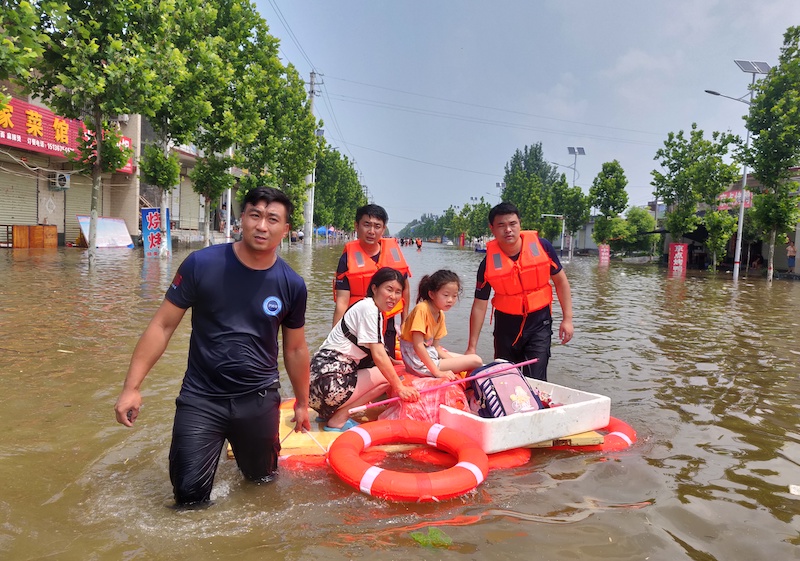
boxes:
[333,204,411,358]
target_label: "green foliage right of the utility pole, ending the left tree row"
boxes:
[314,146,367,230]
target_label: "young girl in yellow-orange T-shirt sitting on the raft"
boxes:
[400,269,483,380]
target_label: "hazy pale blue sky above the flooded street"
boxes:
[256,0,800,232]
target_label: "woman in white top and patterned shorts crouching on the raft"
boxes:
[309,267,419,431]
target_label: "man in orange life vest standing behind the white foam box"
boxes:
[466,202,573,380]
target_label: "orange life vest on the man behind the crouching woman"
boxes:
[333,238,411,318]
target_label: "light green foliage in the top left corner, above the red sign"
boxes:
[0,0,50,108]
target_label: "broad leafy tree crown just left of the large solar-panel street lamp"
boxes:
[651,123,737,242]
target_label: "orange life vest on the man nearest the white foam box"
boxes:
[484,231,553,316]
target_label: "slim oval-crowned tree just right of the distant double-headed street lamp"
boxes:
[589,160,628,244]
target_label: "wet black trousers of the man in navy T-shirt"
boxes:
[169,389,281,506]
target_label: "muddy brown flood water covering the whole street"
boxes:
[0,244,800,561]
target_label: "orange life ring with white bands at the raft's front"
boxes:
[328,419,489,502]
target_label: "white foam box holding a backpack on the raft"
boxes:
[439,379,611,454]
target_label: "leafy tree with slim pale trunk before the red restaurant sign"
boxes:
[25,0,173,269]
